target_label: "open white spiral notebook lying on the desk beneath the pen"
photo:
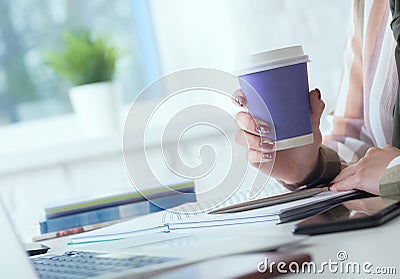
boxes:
[70,179,341,244]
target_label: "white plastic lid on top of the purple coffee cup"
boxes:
[236,46,310,76]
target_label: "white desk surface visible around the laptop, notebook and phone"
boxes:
[43,213,400,278]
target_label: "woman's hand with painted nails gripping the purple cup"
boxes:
[234,89,325,188]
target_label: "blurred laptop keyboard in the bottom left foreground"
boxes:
[31,251,177,279]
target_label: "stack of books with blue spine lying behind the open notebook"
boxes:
[34,182,196,241]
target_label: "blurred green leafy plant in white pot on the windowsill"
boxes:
[45,29,119,86]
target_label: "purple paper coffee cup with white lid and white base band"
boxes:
[236,46,313,150]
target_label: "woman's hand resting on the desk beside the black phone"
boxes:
[330,145,400,195]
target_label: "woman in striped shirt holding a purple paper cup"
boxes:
[235,0,400,195]
